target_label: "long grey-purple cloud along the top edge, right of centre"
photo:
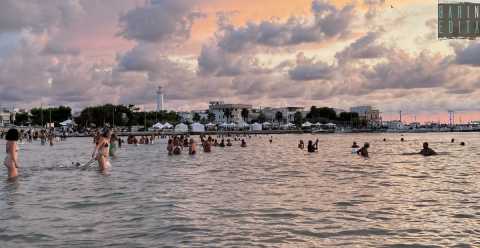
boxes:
[217,0,354,53]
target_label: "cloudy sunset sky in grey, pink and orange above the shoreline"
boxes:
[0,0,480,121]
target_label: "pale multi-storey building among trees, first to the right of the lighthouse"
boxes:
[208,101,252,123]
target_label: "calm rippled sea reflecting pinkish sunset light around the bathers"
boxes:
[0,133,480,248]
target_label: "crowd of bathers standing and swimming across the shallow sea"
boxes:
[0,128,465,179]
